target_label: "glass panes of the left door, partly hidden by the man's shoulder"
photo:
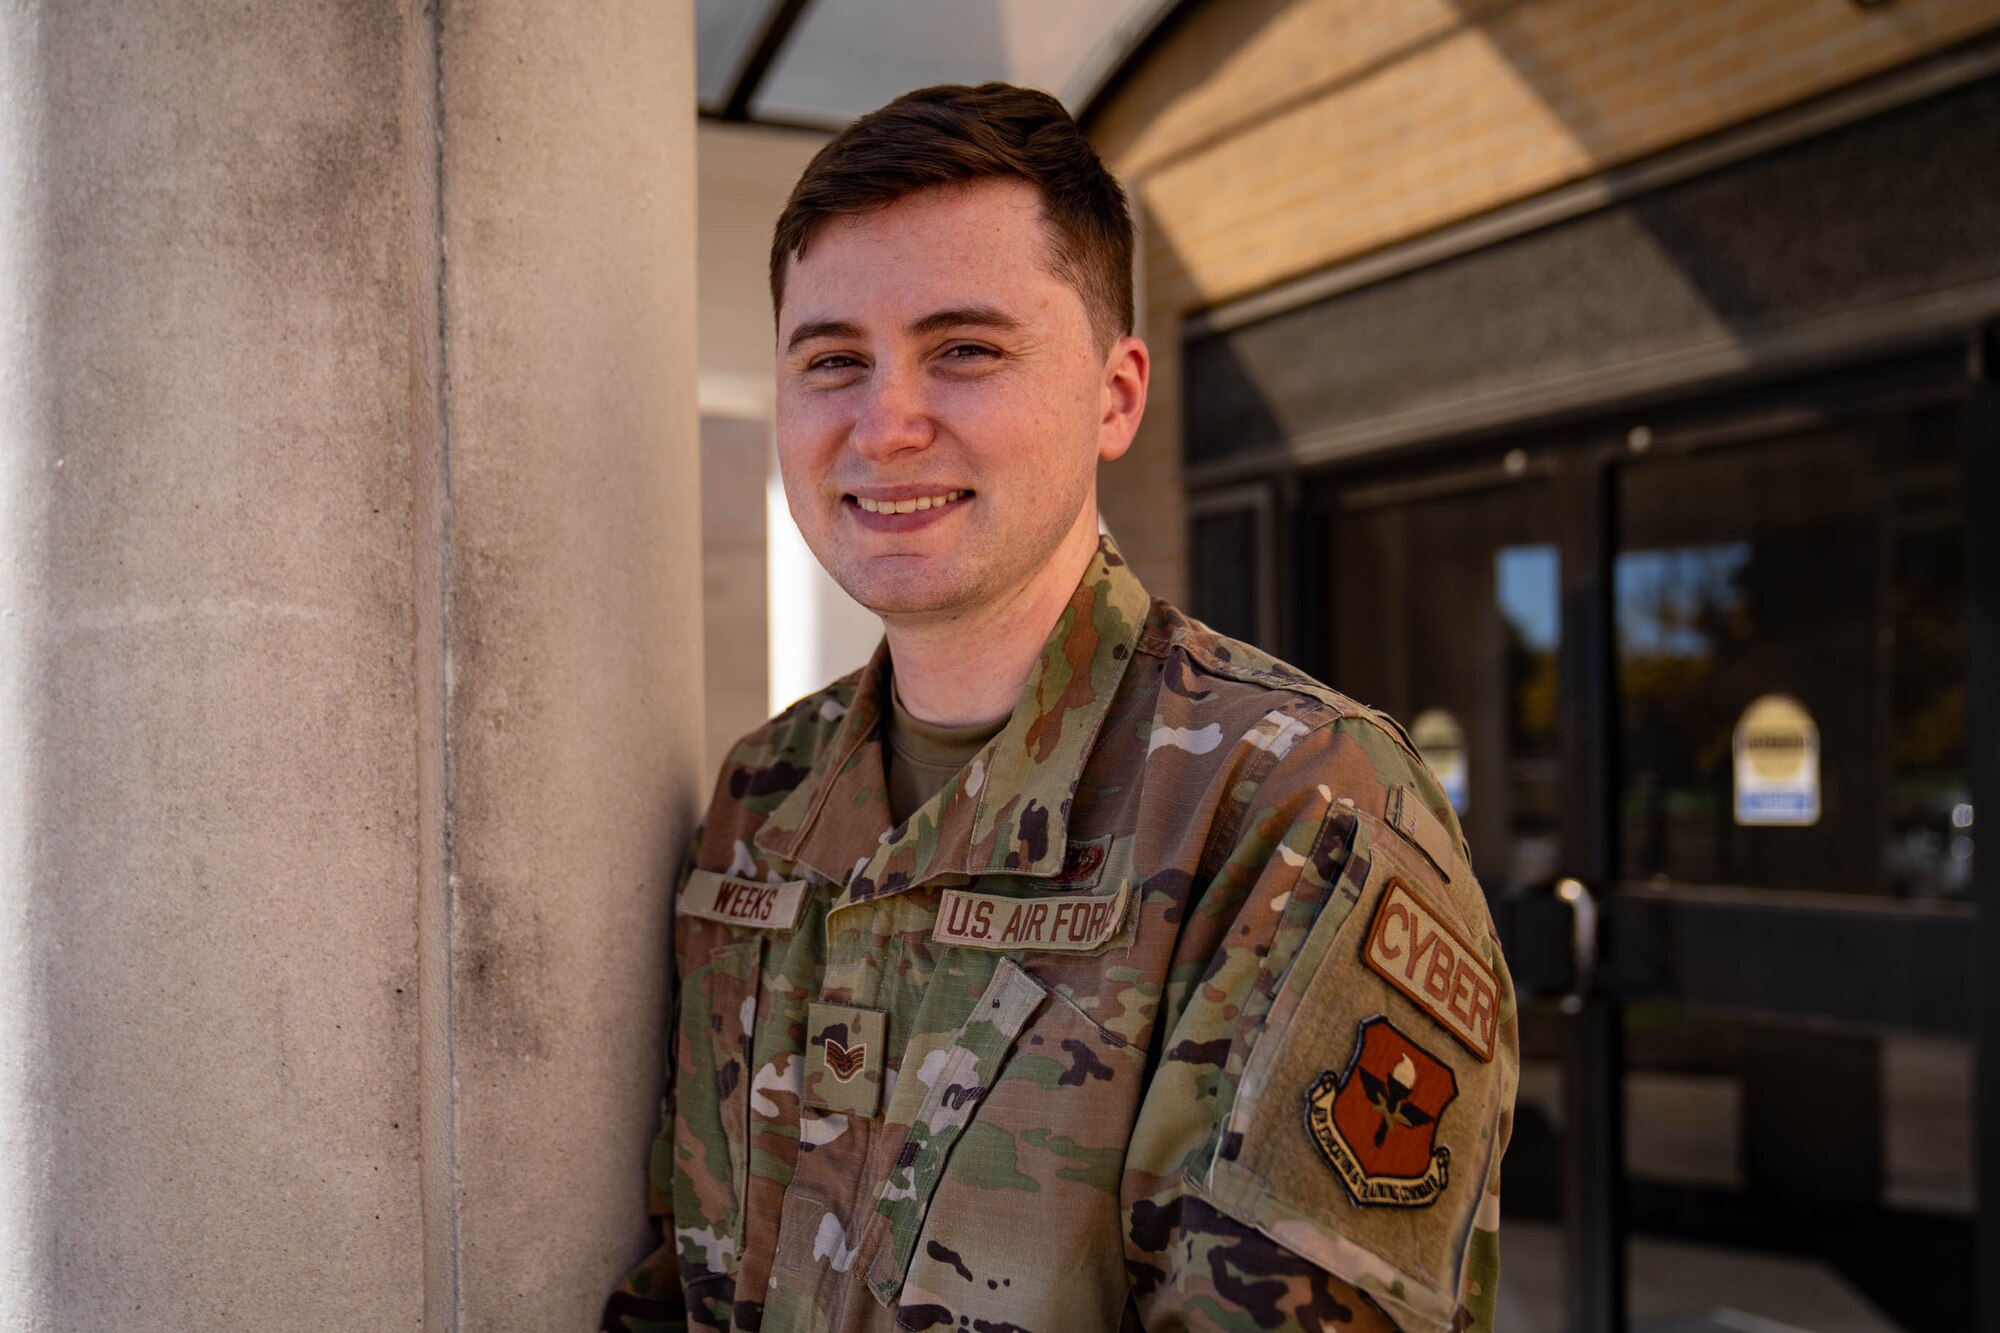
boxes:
[1328,458,1600,1333]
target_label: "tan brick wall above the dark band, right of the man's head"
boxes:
[1092,0,2000,596]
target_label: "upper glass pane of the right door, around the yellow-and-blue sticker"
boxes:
[1614,408,1972,899]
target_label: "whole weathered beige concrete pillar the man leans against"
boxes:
[0,0,704,1333]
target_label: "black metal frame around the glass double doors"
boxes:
[1276,328,2000,1333]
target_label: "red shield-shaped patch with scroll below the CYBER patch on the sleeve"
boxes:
[1306,1015,1458,1209]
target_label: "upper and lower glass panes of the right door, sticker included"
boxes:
[1612,404,1976,1333]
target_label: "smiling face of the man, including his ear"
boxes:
[778,180,1146,622]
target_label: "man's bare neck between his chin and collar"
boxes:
[882,504,1098,727]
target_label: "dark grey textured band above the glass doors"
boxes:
[1188,6,2000,460]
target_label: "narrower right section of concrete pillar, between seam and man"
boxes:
[442,0,706,1329]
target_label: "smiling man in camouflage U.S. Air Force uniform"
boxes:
[604,86,1518,1333]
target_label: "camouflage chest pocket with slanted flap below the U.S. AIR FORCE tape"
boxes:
[864,957,1140,1329]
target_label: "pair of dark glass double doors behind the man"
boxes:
[1312,362,1996,1333]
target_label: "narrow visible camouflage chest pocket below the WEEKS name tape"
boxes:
[674,939,762,1293]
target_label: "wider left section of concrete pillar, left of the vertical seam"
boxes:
[0,0,422,1329]
